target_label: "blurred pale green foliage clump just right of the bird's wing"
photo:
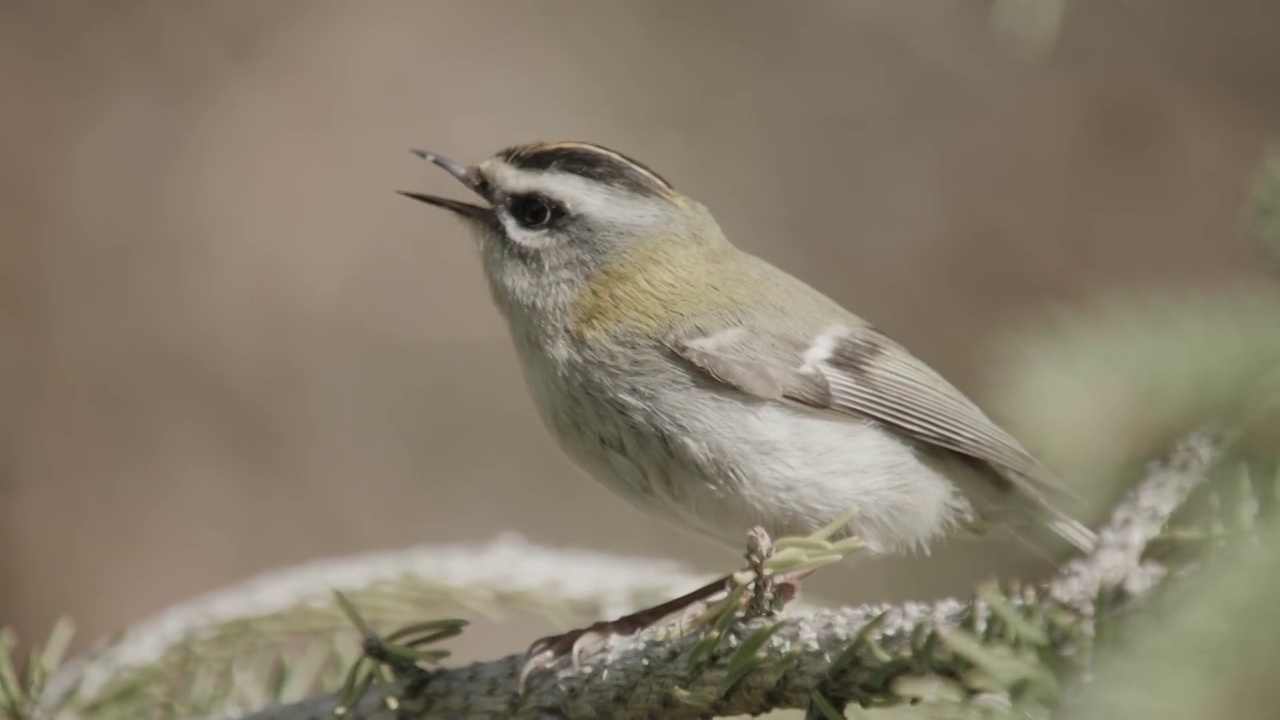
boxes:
[989,287,1280,506]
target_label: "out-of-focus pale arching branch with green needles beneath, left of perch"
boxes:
[32,536,721,720]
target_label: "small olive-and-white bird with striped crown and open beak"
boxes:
[401,142,1093,671]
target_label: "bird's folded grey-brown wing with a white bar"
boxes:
[668,320,1092,548]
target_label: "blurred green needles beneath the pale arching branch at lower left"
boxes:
[16,577,614,720]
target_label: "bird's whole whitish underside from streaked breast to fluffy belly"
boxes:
[509,327,980,552]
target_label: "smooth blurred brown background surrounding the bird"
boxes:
[0,0,1280,650]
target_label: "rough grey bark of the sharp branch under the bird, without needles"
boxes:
[225,437,1212,720]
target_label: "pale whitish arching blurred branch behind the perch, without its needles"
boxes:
[41,534,721,717]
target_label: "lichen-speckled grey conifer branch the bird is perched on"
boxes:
[232,430,1212,720]
